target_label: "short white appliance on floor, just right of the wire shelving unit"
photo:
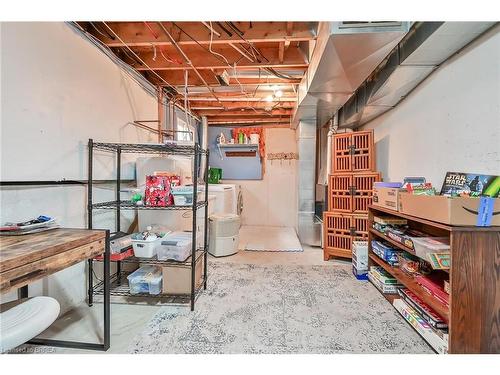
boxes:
[208,213,240,257]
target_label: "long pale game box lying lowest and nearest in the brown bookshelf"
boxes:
[392,298,448,354]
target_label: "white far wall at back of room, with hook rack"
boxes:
[223,128,298,228]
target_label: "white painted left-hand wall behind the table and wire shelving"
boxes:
[0,22,157,310]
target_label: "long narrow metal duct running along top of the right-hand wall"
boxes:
[338,22,495,128]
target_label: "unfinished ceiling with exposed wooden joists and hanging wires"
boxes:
[78,22,317,125]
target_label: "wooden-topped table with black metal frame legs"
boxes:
[0,228,110,350]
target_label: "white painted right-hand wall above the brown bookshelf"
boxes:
[364,27,500,189]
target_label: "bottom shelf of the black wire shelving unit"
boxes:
[94,272,205,305]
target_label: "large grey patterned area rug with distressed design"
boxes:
[128,263,432,353]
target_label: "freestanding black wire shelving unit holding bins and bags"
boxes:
[87,139,209,310]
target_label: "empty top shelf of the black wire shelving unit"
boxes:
[92,142,208,156]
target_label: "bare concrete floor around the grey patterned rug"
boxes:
[19,245,345,354]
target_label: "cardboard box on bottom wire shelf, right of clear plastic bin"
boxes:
[162,256,203,294]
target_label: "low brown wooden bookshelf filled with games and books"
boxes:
[368,205,500,353]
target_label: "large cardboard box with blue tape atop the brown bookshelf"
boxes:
[399,192,500,226]
